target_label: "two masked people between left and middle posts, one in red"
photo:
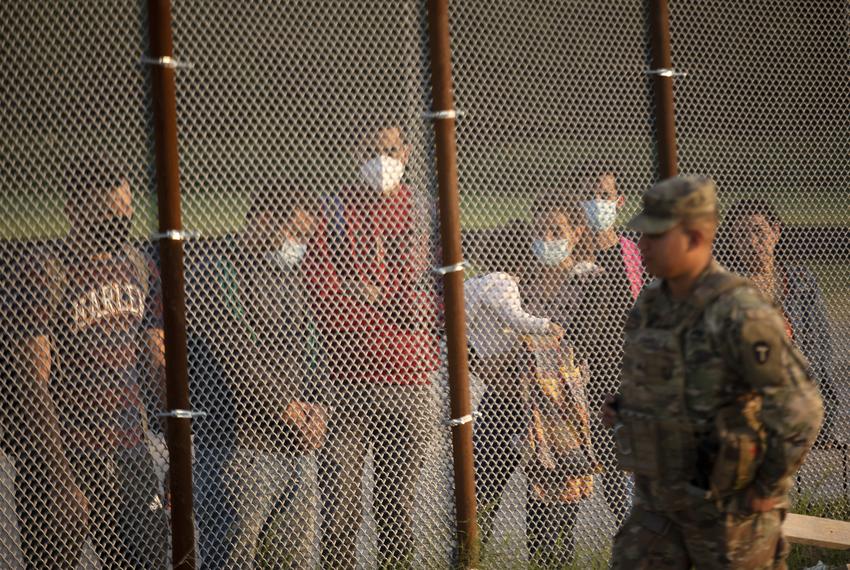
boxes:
[186,121,440,568]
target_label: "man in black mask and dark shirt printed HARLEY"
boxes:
[12,159,168,568]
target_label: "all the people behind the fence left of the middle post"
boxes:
[0,124,440,568]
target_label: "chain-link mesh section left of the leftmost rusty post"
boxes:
[0,2,169,568]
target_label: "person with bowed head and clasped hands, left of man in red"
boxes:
[187,183,325,568]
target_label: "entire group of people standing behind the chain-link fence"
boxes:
[0,117,833,568]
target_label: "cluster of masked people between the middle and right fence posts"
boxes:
[466,167,644,567]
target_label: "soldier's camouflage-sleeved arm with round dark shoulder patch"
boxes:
[728,302,823,498]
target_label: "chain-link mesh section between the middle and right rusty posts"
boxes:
[452,2,653,568]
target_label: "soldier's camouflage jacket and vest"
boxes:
[615,263,823,511]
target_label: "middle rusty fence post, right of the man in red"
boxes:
[428,0,479,568]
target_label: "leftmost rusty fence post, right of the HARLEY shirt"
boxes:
[148,0,195,570]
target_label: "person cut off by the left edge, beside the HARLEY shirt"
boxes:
[0,254,88,568]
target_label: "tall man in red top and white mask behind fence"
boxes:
[304,125,438,568]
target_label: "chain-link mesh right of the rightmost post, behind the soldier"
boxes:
[670,0,850,520]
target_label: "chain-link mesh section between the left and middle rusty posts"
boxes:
[174,1,453,568]
